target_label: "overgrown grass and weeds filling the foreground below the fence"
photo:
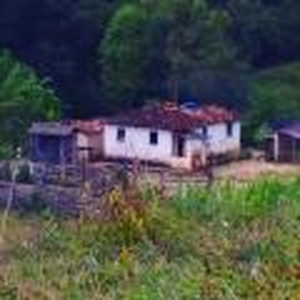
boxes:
[0,178,300,300]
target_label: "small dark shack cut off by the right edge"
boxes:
[266,121,300,163]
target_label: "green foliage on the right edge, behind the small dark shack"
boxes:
[244,62,300,142]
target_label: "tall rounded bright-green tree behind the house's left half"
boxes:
[100,4,154,107]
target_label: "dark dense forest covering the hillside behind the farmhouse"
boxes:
[0,0,300,151]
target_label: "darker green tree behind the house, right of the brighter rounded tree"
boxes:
[156,0,235,100]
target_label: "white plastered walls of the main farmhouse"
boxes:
[104,122,241,168]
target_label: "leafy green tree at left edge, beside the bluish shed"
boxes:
[0,51,59,155]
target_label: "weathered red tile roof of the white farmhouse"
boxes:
[108,102,239,132]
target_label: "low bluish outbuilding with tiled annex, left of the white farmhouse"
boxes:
[29,120,104,164]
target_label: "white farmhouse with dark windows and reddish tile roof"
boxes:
[104,102,241,169]
